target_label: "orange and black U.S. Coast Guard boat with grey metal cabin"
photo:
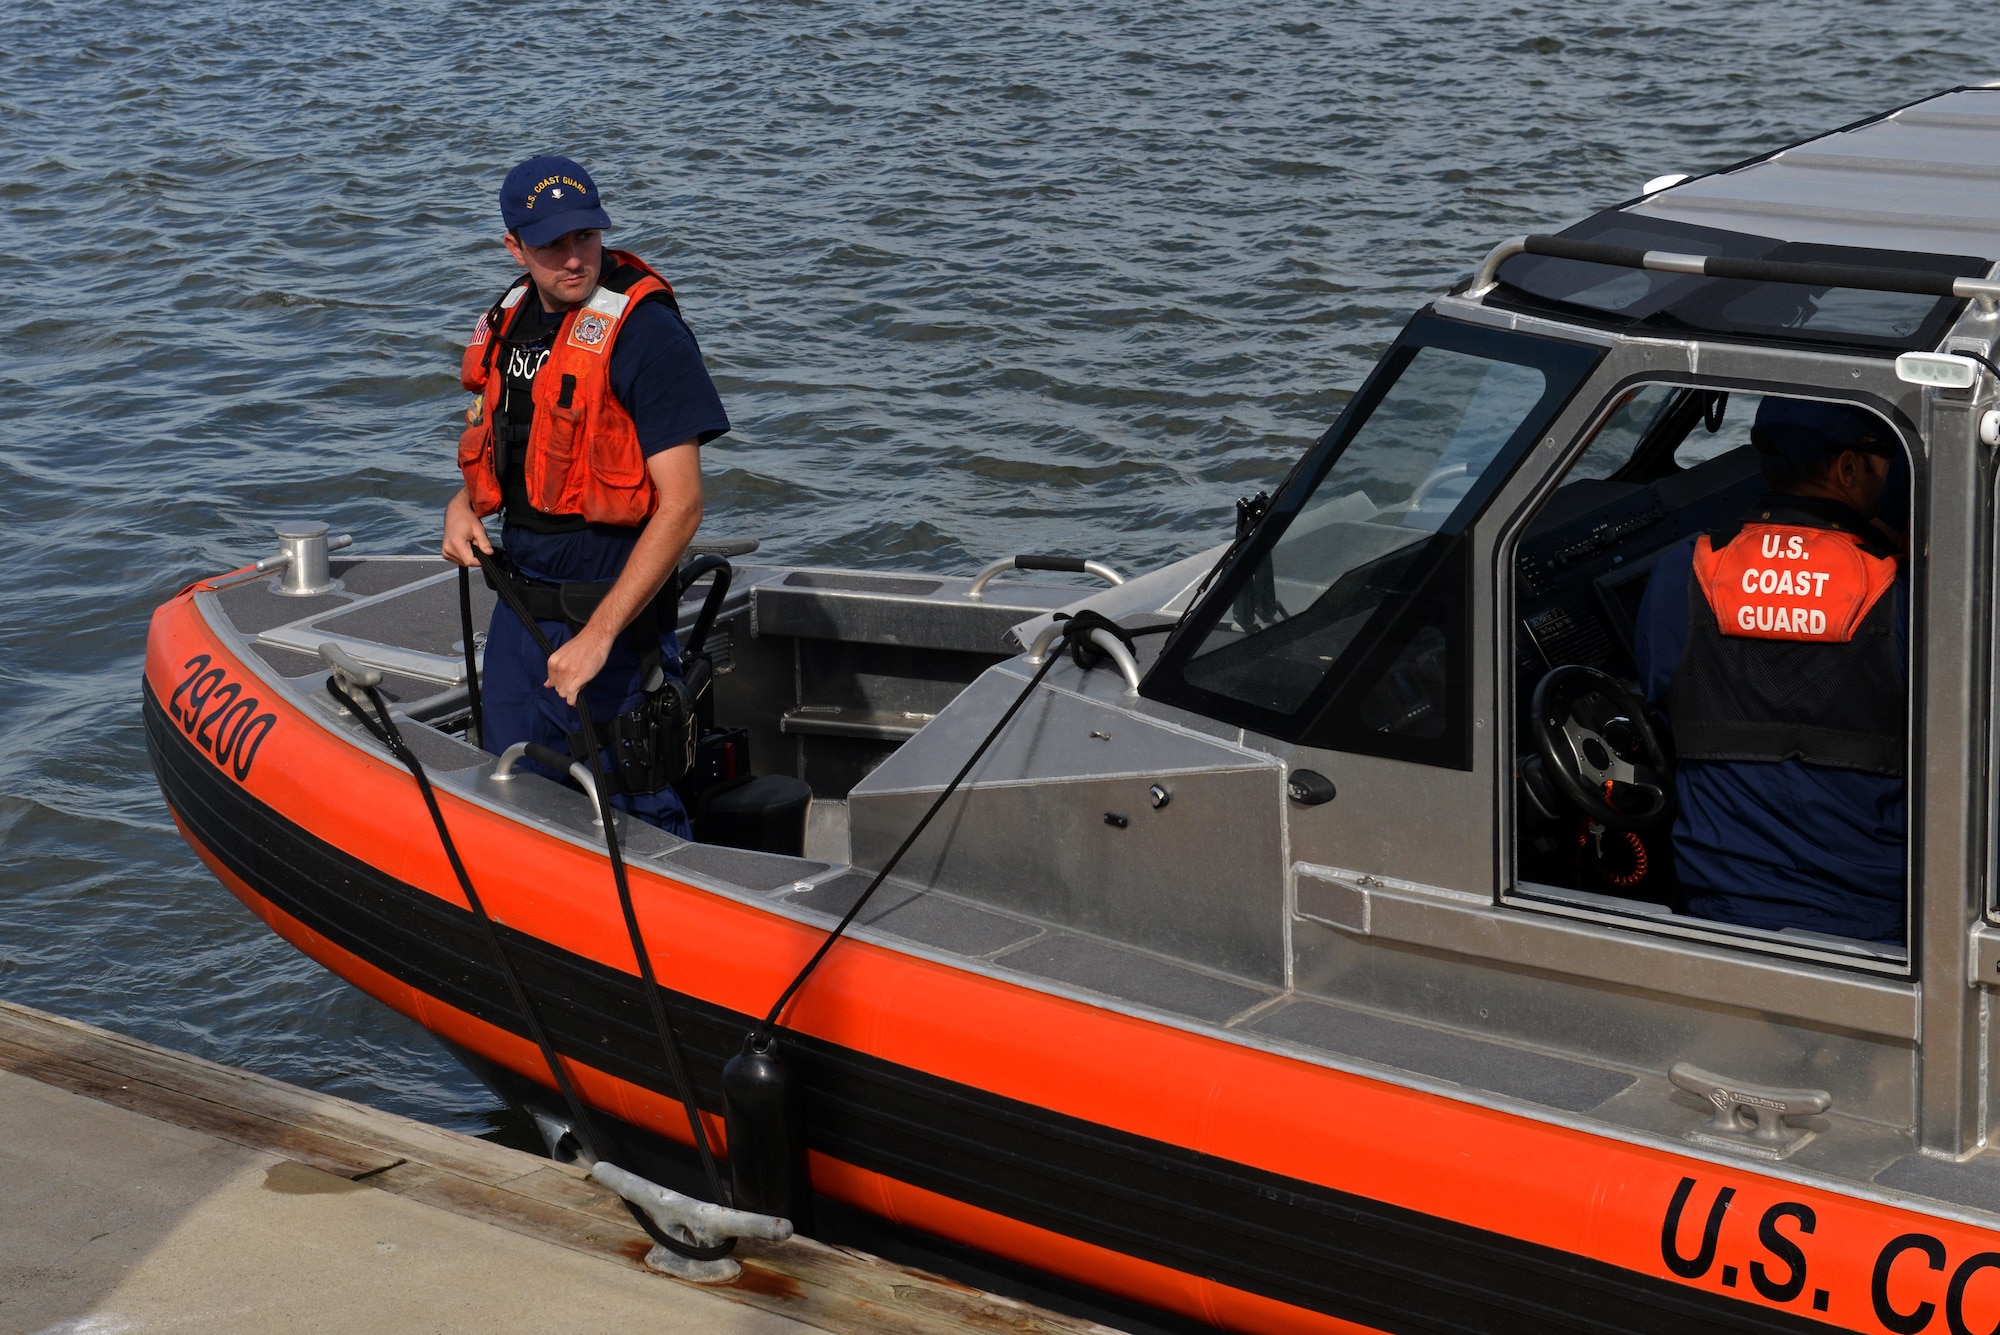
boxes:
[144,88,2000,1335]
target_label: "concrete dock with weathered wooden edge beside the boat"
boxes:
[0,1001,1106,1335]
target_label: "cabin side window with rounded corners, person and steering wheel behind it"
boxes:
[1510,384,1912,971]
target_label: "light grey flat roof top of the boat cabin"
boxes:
[1620,86,2000,260]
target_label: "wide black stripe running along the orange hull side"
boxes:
[146,683,1830,1335]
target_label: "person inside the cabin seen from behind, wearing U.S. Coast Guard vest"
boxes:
[1634,398,1910,943]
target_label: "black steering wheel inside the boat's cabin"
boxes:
[1530,664,1674,829]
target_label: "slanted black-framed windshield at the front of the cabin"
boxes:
[1148,316,1598,765]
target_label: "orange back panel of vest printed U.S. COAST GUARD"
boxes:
[1694,524,1896,644]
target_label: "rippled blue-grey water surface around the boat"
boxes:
[0,0,2000,1131]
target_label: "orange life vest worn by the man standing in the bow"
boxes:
[458,250,674,526]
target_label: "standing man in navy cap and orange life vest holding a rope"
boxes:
[444,156,730,837]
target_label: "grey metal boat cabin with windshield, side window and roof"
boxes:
[816,90,2000,1175]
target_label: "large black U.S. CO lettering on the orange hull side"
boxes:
[1660,1177,2000,1335]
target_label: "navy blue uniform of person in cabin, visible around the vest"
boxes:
[1634,540,1910,943]
